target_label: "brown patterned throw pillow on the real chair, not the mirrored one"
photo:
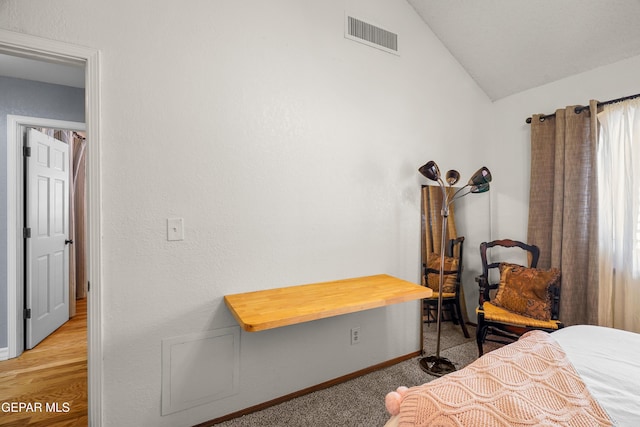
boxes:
[493,263,560,321]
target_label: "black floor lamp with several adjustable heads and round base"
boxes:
[418,160,491,377]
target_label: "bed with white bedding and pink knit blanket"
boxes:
[385,325,640,427]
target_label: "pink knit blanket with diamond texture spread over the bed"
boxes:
[399,331,613,427]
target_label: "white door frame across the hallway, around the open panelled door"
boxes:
[7,114,86,359]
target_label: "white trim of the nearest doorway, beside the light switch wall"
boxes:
[0,29,103,427]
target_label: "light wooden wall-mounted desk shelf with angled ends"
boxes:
[224,274,432,332]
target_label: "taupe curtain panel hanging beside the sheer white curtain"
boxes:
[527,101,598,325]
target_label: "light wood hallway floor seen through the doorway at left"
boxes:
[0,299,88,427]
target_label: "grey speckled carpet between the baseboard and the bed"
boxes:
[217,322,497,427]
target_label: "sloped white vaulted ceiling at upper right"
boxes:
[407,0,640,100]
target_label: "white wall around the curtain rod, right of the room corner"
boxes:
[487,56,640,240]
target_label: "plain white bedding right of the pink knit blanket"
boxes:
[385,325,640,427]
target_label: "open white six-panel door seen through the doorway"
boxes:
[25,129,70,349]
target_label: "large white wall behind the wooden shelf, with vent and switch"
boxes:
[0,0,490,426]
